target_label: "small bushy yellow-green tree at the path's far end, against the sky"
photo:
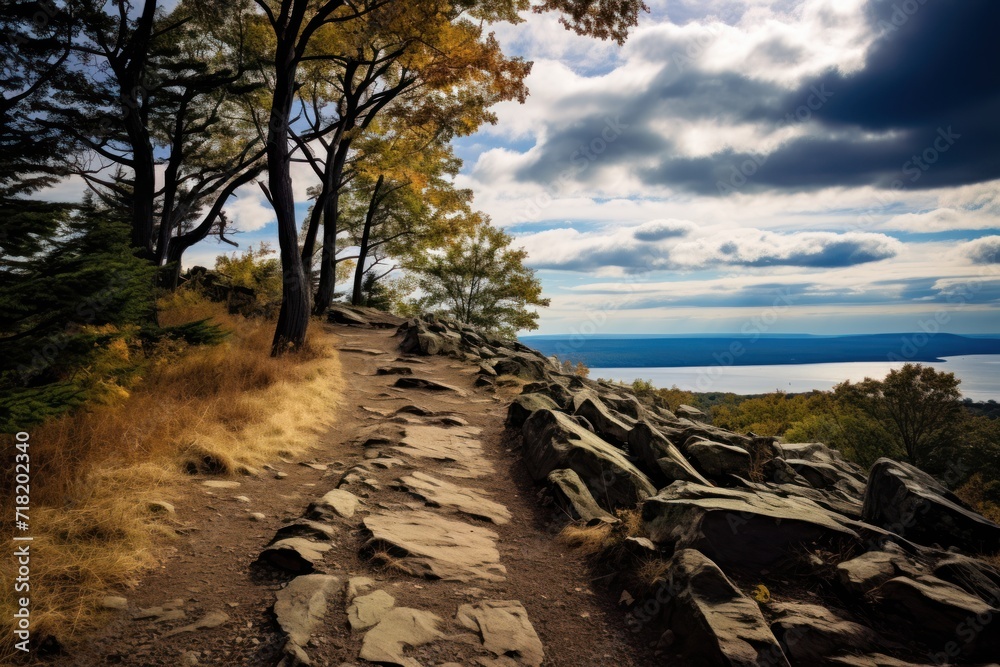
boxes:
[413,217,549,338]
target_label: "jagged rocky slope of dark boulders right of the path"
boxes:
[392,311,1000,665]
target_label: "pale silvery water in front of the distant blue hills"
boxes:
[590,354,1000,401]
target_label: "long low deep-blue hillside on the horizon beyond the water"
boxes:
[521,333,1000,368]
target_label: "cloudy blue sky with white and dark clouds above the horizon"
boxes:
[43,0,1000,334]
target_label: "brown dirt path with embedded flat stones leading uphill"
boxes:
[56,327,654,667]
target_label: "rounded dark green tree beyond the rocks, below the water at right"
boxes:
[835,364,962,472]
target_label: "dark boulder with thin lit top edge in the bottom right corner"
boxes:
[870,575,1000,662]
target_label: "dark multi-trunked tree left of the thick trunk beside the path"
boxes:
[38,0,263,274]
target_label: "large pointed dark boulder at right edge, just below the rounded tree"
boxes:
[862,458,1000,553]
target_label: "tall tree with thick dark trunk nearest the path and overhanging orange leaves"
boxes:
[255,0,646,354]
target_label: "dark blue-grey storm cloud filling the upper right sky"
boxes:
[518,0,1000,194]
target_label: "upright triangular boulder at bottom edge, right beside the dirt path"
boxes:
[661,549,788,667]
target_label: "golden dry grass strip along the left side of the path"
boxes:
[0,296,342,663]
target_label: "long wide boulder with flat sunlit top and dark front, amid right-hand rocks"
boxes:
[642,482,862,566]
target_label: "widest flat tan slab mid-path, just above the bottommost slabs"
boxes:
[364,510,507,582]
